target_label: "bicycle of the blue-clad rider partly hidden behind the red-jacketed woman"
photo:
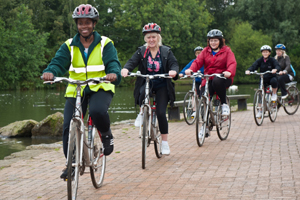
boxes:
[180,73,199,125]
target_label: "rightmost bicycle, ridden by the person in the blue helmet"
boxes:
[277,81,300,115]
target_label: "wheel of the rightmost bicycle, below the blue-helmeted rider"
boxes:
[284,85,300,115]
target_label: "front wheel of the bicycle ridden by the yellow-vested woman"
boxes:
[67,121,80,200]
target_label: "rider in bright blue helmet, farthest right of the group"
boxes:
[274,44,294,99]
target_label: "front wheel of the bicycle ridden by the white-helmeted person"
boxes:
[253,90,264,126]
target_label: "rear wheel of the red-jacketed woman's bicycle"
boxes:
[216,97,231,140]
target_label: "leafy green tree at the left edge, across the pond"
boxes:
[0,4,49,89]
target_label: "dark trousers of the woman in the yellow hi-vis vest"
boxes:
[63,89,113,158]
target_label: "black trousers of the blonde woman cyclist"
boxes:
[139,85,169,134]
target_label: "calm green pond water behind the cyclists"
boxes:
[0,81,284,159]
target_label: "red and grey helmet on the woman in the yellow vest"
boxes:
[72,4,99,21]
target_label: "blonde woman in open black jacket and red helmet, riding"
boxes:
[121,23,179,155]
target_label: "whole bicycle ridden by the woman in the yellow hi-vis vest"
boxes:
[44,77,107,200]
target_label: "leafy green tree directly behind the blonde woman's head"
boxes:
[115,0,212,68]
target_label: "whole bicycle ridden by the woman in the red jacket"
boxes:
[196,72,231,147]
